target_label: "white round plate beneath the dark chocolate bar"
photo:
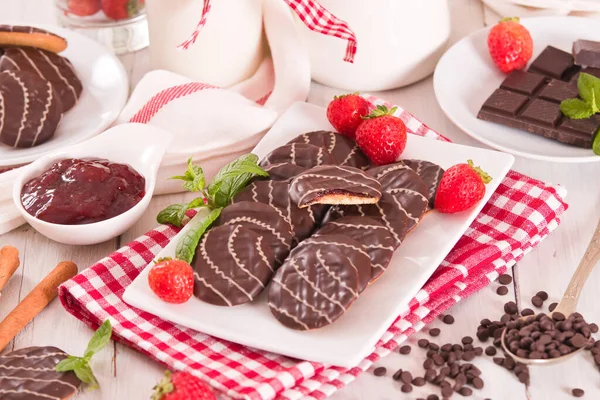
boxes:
[433,17,600,162]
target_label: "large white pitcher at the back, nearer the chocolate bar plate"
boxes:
[297,0,450,91]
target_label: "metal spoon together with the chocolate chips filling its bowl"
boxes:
[501,222,600,365]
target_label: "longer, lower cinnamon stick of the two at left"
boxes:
[0,261,77,351]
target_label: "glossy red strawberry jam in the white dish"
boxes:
[21,158,146,225]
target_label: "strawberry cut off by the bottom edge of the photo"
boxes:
[151,371,217,400]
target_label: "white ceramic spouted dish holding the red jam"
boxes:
[12,124,172,245]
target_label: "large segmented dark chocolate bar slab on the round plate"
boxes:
[477,46,600,148]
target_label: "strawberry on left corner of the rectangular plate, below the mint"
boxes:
[148,258,194,304]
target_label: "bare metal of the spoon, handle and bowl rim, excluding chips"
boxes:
[500,222,600,365]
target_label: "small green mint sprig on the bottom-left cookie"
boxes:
[56,319,112,389]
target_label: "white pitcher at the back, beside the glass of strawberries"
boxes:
[146,0,265,86]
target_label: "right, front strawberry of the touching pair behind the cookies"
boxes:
[356,106,406,165]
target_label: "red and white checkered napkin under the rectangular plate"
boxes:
[59,98,567,400]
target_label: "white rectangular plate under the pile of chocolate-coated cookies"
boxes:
[123,103,514,367]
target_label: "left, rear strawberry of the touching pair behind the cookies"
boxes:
[327,93,371,139]
